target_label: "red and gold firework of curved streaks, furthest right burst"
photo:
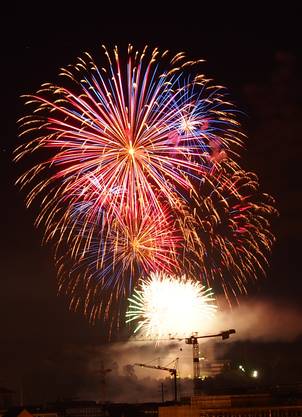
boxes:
[178,164,277,304]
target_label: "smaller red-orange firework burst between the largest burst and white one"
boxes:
[57,203,182,322]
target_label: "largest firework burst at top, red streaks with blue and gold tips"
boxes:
[16,47,241,230]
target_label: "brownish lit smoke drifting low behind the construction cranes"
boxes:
[10,301,302,404]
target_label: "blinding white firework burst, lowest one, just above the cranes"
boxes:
[126,273,216,339]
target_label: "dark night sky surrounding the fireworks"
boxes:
[0,2,302,401]
